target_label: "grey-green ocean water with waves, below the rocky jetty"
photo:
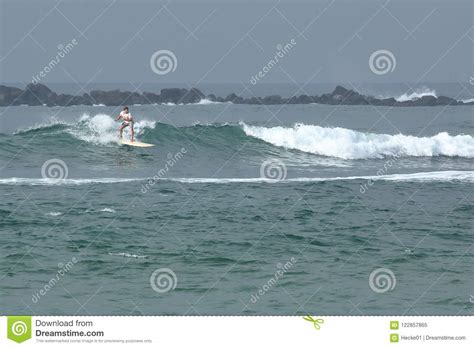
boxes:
[0,90,474,315]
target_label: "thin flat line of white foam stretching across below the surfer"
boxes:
[0,170,474,186]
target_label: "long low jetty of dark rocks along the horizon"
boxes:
[0,83,474,106]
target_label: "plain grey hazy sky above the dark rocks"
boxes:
[0,0,474,84]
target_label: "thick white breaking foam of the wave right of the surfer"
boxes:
[242,123,474,159]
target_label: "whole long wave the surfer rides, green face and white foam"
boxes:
[9,117,474,160]
